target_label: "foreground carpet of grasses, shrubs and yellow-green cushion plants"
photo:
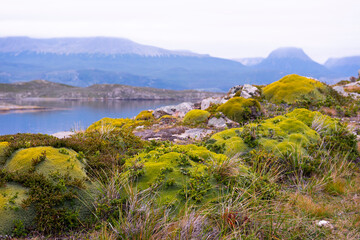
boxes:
[0,75,360,239]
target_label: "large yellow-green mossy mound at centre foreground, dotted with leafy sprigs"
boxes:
[124,145,247,204]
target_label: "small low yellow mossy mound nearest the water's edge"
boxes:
[86,117,143,132]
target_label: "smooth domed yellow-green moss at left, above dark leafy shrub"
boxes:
[5,147,86,179]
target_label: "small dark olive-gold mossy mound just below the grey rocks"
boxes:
[217,97,261,122]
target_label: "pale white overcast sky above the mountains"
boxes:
[0,0,360,63]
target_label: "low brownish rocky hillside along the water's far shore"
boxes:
[0,80,223,100]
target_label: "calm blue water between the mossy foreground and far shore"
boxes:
[0,100,184,135]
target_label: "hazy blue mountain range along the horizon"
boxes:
[0,37,360,91]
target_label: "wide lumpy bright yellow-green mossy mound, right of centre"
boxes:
[208,109,338,157]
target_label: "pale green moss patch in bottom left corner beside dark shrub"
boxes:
[0,183,35,235]
